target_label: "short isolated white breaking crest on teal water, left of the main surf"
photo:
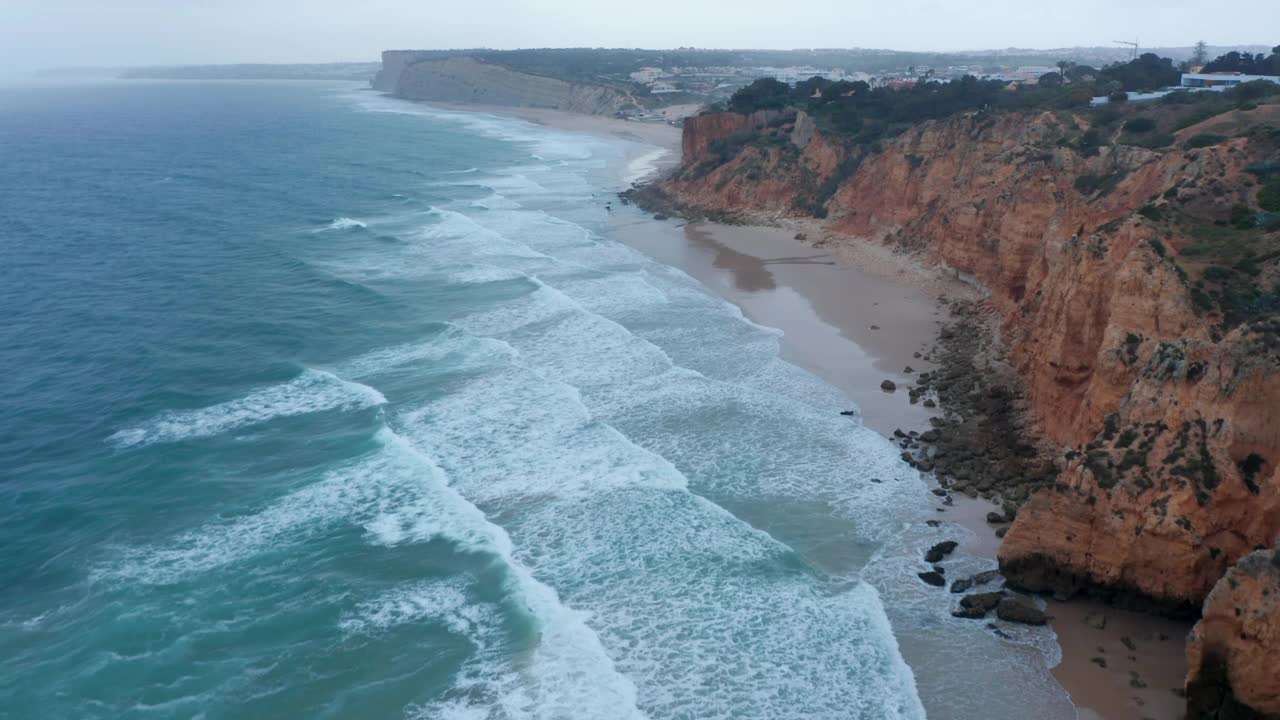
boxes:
[108,368,387,447]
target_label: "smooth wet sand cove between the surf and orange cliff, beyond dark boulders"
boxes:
[614,223,942,434]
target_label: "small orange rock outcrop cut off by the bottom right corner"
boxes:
[1187,548,1280,720]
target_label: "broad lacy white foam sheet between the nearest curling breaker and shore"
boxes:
[394,327,923,719]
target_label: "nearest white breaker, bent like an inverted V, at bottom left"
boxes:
[102,415,645,720]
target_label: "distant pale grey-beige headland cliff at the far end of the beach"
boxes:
[374,50,635,115]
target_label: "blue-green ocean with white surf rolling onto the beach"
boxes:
[0,82,1074,720]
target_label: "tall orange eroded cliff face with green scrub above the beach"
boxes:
[664,106,1280,615]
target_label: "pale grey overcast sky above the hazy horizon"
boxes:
[0,0,1280,70]
